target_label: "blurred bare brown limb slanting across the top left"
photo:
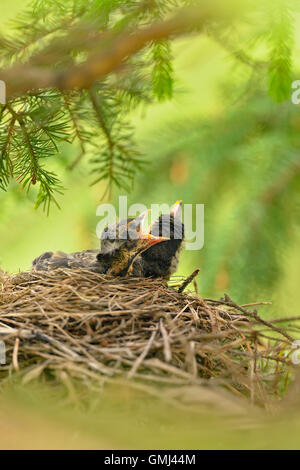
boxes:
[2,1,241,96]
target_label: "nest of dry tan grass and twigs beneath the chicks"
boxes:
[0,270,293,410]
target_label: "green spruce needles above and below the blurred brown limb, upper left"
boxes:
[0,0,193,210]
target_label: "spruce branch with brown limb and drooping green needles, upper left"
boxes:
[0,0,293,207]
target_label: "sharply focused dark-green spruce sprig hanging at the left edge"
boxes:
[0,92,68,212]
